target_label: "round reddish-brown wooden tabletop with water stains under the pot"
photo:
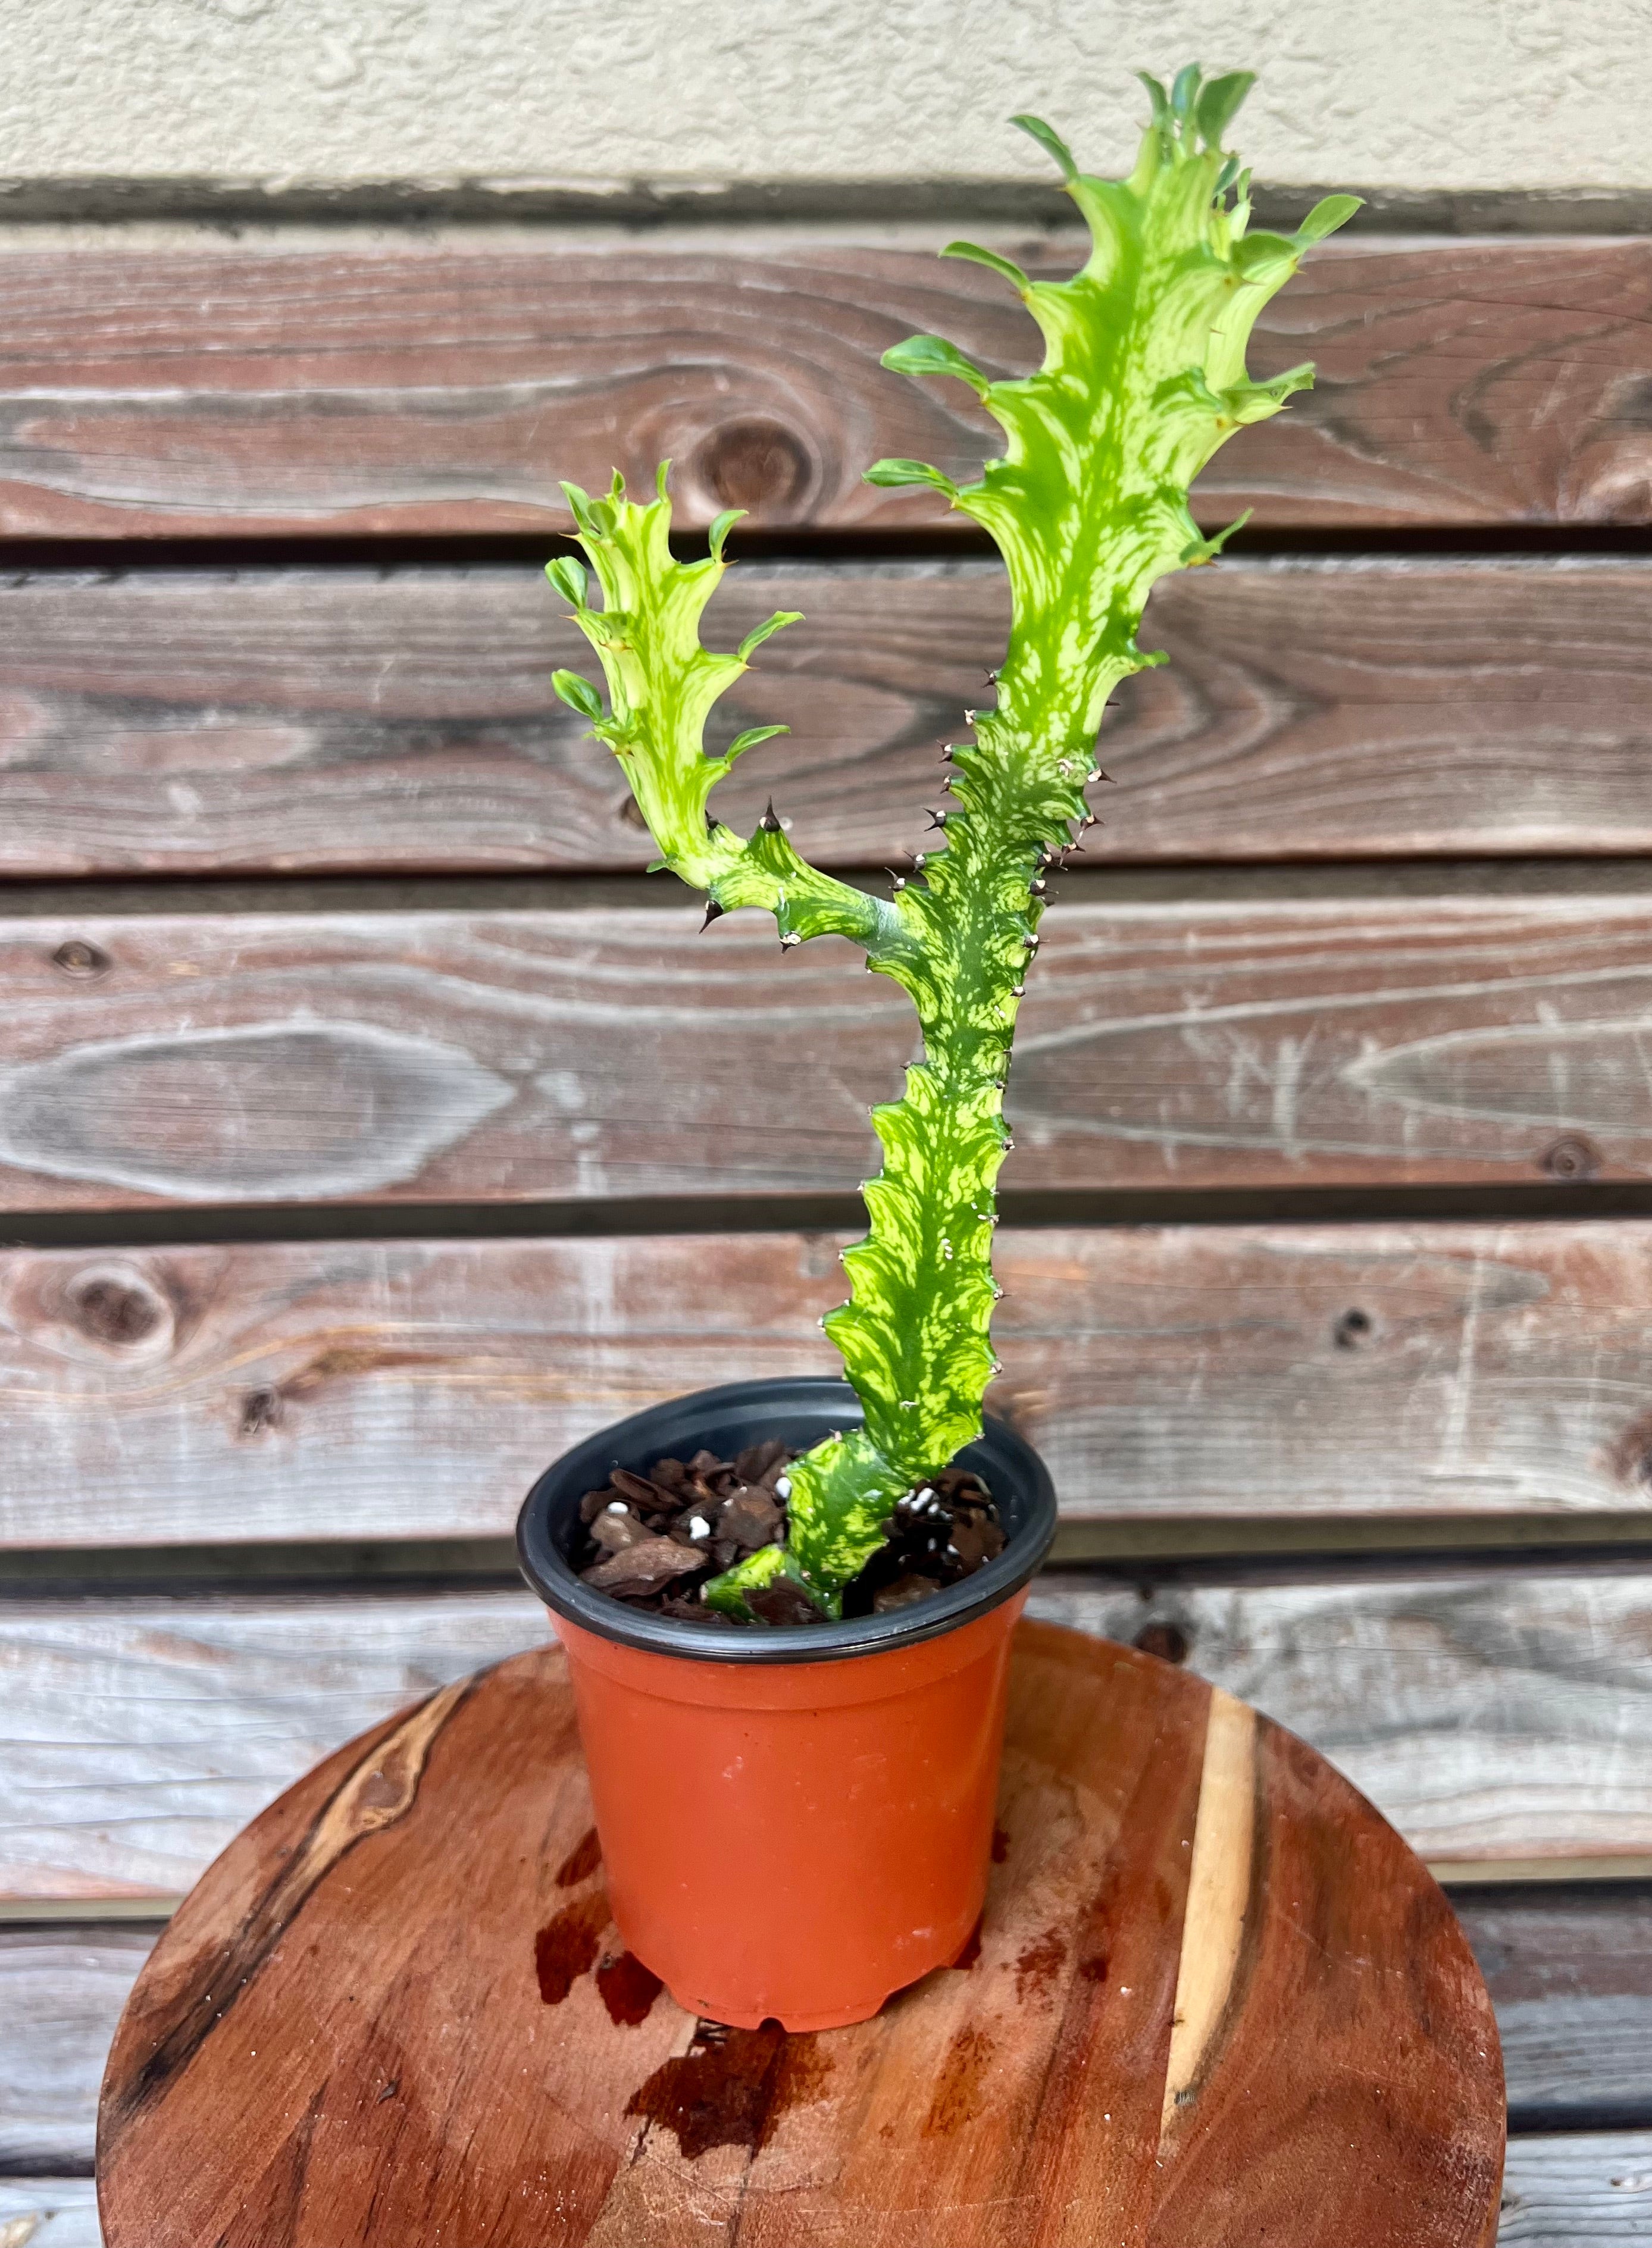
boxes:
[99,1623,1504,2248]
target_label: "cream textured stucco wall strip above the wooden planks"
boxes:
[0,0,1652,189]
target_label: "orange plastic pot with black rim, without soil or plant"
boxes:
[517,1380,1056,2030]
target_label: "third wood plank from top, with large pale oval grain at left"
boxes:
[0,895,1652,1210]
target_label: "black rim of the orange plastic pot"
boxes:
[517,1373,1056,1664]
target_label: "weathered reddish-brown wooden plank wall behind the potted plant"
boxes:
[0,206,1652,2248]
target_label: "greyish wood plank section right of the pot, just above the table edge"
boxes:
[1030,1571,1652,1868]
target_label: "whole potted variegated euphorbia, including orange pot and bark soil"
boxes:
[519,67,1357,2030]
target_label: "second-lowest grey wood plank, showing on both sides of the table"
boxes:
[0,1886,1652,2166]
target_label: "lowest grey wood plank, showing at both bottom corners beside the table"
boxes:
[0,2131,1652,2248]
